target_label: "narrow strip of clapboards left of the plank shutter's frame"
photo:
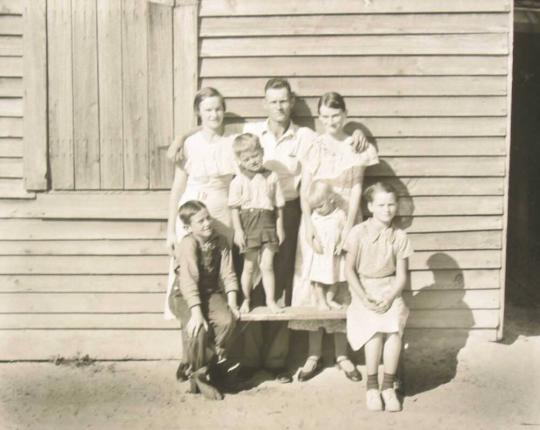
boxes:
[0,0,32,198]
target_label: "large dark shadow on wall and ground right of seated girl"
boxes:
[403,252,474,396]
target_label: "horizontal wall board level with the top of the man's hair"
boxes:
[201,76,506,98]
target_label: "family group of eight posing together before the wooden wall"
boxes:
[165,78,412,411]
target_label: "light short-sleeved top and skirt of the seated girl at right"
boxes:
[345,218,413,350]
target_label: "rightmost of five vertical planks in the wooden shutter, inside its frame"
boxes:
[148,4,173,188]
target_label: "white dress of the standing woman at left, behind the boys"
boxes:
[164,131,237,319]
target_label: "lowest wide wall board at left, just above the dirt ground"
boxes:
[0,329,181,360]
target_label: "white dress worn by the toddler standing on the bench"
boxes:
[309,208,347,285]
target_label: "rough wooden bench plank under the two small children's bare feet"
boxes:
[240,306,346,321]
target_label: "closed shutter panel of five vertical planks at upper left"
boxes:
[47,0,173,190]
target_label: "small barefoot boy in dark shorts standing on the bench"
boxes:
[229,133,285,313]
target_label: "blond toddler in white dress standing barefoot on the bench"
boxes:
[307,181,347,310]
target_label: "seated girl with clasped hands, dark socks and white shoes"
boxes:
[345,182,412,412]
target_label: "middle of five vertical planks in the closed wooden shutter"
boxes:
[97,0,124,189]
